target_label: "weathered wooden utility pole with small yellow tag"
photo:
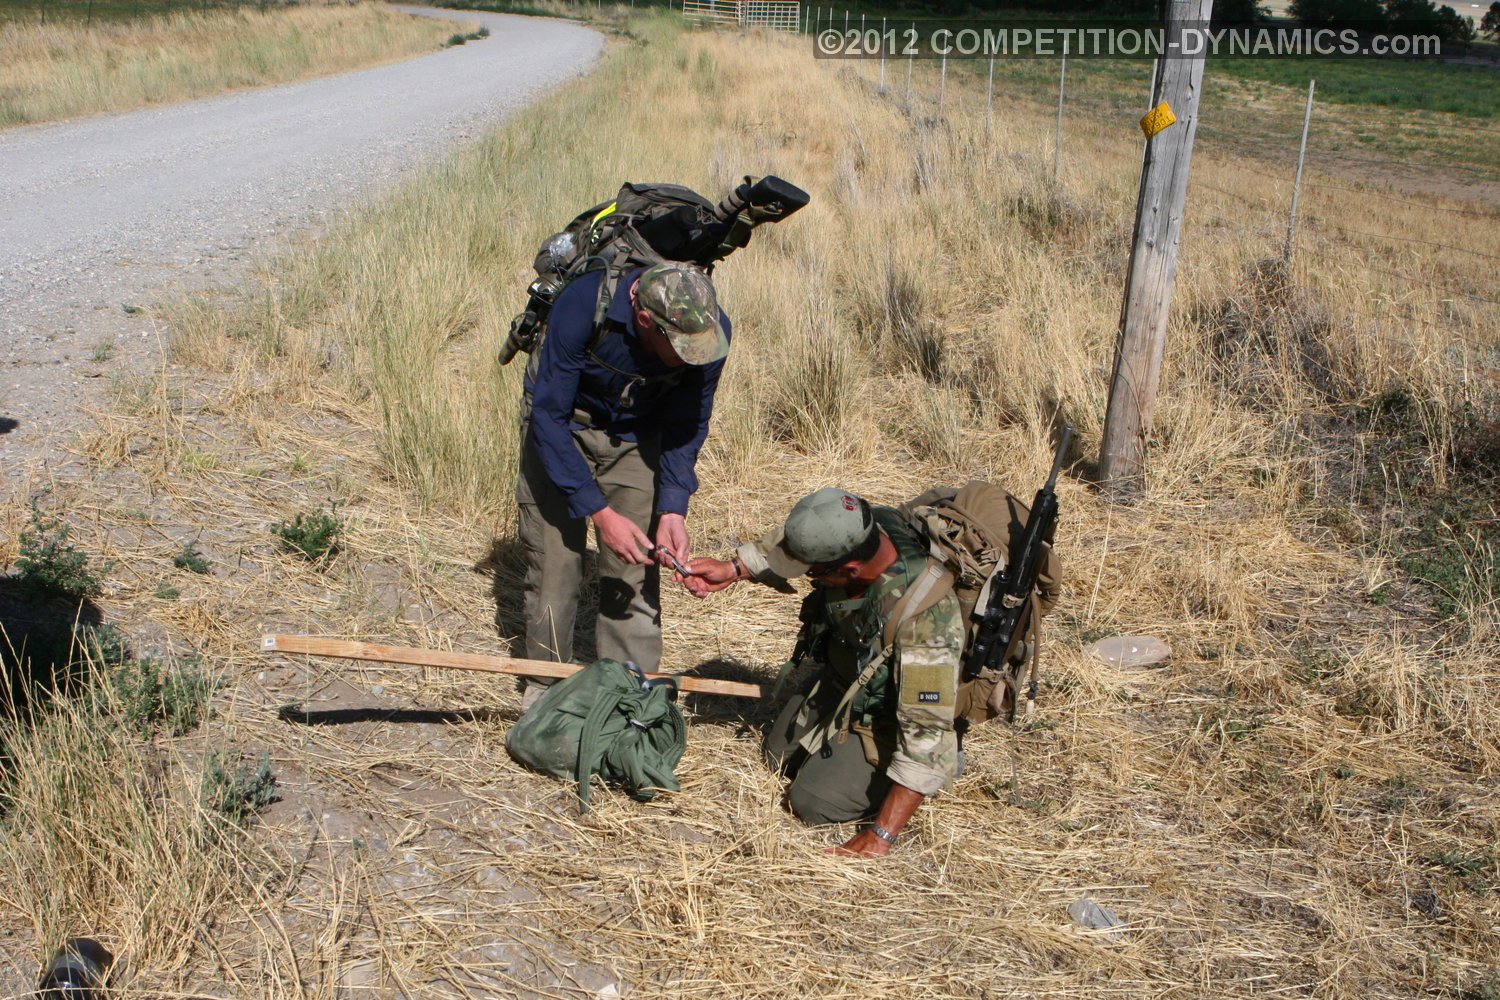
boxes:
[1100,0,1214,493]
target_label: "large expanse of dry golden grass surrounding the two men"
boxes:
[0,9,1500,1000]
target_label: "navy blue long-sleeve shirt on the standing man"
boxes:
[527,268,731,517]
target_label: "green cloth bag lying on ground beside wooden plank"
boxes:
[506,660,687,813]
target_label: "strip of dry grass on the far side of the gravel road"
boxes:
[0,3,468,127]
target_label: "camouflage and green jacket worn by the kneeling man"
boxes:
[737,507,966,795]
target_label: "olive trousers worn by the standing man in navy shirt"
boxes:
[516,424,662,684]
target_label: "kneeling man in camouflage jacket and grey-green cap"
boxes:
[687,487,966,855]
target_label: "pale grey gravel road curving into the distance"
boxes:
[0,7,603,498]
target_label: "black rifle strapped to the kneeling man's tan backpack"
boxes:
[963,427,1073,712]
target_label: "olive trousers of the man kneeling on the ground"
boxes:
[762,694,891,825]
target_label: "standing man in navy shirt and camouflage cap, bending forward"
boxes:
[516,264,731,708]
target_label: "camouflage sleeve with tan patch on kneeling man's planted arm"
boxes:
[885,594,965,795]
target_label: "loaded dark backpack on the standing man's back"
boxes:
[500,177,809,364]
